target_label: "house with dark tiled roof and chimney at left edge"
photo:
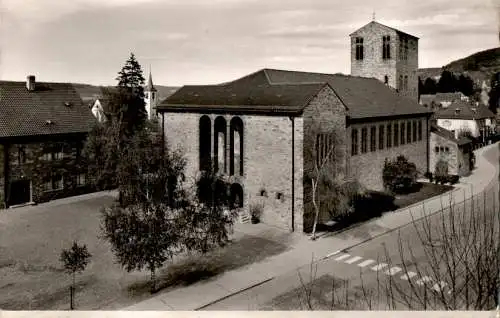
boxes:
[0,76,95,207]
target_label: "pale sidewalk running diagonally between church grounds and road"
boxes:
[124,144,498,310]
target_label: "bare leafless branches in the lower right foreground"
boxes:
[299,186,500,310]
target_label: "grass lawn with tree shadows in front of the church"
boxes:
[0,196,288,310]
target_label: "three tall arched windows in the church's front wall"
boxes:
[199,115,243,176]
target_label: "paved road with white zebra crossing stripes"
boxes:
[203,148,499,310]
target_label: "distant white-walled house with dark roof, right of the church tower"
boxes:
[433,101,496,139]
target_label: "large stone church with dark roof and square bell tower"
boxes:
[157,22,432,231]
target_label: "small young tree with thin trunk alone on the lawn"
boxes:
[60,241,92,310]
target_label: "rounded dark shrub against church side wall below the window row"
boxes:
[382,155,417,193]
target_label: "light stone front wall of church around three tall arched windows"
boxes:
[164,112,303,231]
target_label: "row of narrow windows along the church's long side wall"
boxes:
[351,120,422,156]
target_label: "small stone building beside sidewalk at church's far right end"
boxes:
[429,125,472,176]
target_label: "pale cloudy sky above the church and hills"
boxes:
[0,0,500,86]
